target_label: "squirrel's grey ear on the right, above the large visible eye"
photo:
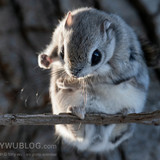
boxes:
[101,19,113,39]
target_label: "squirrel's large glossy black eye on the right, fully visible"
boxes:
[91,49,102,66]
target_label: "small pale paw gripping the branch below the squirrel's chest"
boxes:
[68,106,86,119]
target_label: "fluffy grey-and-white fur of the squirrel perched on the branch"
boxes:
[39,8,149,152]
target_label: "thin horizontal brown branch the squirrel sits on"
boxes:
[0,110,160,125]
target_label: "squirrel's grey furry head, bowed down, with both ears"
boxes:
[37,8,115,78]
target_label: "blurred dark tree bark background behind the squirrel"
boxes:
[0,0,160,160]
